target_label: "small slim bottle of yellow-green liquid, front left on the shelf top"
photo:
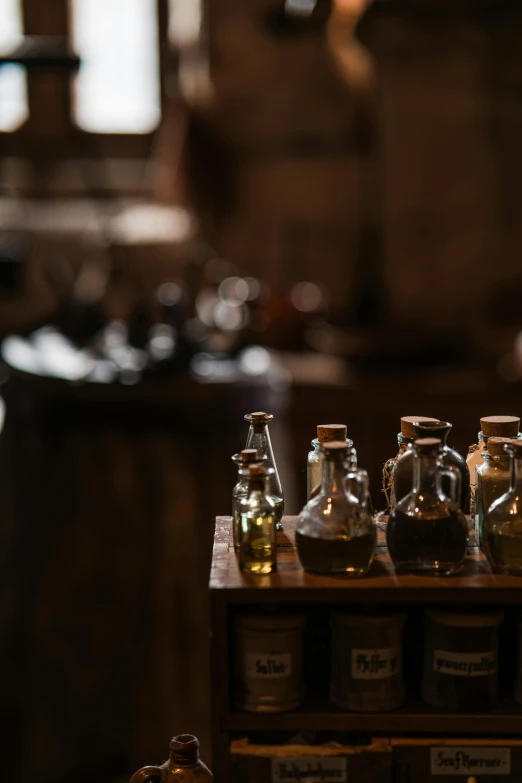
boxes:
[239,464,277,574]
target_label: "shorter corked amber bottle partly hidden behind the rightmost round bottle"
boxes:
[475,438,511,547]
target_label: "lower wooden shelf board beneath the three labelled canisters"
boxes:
[221,703,522,735]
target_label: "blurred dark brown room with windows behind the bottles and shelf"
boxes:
[0,0,522,783]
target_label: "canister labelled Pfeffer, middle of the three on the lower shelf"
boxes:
[330,610,406,712]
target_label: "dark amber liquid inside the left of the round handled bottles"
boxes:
[295,532,375,576]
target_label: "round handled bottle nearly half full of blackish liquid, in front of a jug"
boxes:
[386,438,468,575]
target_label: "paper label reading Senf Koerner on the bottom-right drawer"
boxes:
[430,747,511,777]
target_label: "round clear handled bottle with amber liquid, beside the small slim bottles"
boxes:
[295,441,376,576]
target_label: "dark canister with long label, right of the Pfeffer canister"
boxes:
[422,610,504,712]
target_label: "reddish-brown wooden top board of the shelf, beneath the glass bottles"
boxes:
[210,517,522,604]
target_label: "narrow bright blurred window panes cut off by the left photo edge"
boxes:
[0,0,29,132]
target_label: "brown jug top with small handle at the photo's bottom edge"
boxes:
[130,734,214,783]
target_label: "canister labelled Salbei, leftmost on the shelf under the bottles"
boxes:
[235,614,305,712]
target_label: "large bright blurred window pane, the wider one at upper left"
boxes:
[71,0,160,133]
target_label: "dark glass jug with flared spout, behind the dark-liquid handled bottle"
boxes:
[393,419,469,511]
